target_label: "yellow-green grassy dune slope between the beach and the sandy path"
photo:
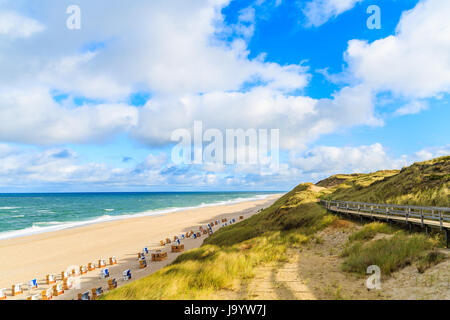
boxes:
[103,184,335,300]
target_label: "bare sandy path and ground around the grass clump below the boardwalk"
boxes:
[241,219,450,300]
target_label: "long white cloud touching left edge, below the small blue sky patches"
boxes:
[0,87,138,144]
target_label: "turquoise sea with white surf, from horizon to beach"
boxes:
[0,192,273,239]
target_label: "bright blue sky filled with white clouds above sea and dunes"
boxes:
[0,0,450,192]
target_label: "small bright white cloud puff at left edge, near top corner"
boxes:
[0,10,45,39]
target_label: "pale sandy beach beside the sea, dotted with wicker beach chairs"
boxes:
[0,194,281,300]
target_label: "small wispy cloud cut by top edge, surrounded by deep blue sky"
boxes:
[302,0,363,27]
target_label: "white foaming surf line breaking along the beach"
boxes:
[0,194,273,240]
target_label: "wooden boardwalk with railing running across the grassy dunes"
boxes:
[320,200,450,248]
